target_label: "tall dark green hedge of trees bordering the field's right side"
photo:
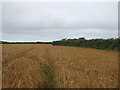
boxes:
[52,38,120,50]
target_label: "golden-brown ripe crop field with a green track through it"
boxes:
[2,44,118,88]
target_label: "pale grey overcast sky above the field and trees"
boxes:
[0,2,118,41]
